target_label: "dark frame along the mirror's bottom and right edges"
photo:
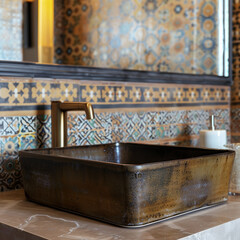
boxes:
[0,0,233,86]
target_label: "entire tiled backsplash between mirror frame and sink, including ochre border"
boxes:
[0,77,230,191]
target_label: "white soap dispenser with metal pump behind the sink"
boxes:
[200,115,227,149]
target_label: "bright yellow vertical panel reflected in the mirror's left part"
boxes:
[38,0,54,63]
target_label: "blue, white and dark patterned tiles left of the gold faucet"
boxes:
[0,115,51,191]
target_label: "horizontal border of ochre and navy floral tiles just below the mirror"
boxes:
[0,78,230,113]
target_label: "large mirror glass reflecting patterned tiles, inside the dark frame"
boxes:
[0,0,231,77]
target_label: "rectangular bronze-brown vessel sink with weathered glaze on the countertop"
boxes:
[20,143,235,227]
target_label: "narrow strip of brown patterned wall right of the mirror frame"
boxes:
[231,0,240,142]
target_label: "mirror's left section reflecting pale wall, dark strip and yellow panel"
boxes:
[0,0,54,63]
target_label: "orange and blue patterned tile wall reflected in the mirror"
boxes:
[55,0,223,75]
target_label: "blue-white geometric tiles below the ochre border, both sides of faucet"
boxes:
[0,109,229,191]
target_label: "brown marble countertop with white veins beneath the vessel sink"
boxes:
[0,190,240,240]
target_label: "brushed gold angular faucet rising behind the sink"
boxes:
[51,101,94,147]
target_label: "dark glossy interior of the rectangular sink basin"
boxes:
[28,143,231,164]
